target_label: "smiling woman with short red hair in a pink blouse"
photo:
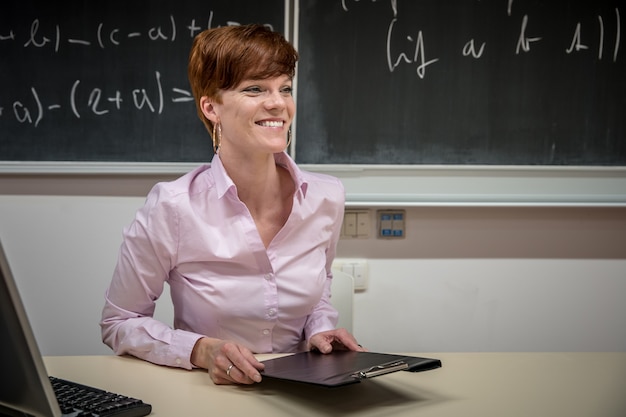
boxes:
[101,25,363,384]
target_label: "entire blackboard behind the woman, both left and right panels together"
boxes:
[0,0,626,166]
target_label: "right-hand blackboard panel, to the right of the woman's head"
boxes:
[296,0,626,166]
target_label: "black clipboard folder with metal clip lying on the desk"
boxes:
[261,350,441,387]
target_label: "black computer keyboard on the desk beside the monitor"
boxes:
[50,376,152,417]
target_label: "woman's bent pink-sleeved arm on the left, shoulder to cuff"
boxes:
[100,185,202,369]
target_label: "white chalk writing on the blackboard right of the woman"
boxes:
[339,0,622,79]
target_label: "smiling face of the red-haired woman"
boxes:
[202,75,295,153]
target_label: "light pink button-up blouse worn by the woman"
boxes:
[100,153,345,369]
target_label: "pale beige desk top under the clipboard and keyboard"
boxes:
[44,352,626,417]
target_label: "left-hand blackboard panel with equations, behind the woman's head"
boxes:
[0,0,285,162]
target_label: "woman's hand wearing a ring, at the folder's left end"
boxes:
[191,337,265,385]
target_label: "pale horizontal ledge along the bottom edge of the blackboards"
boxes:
[0,161,626,208]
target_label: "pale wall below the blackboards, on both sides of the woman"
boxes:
[0,174,626,355]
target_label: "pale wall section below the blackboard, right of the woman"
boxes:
[340,207,626,352]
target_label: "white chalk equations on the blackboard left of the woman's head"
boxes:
[0,11,273,128]
